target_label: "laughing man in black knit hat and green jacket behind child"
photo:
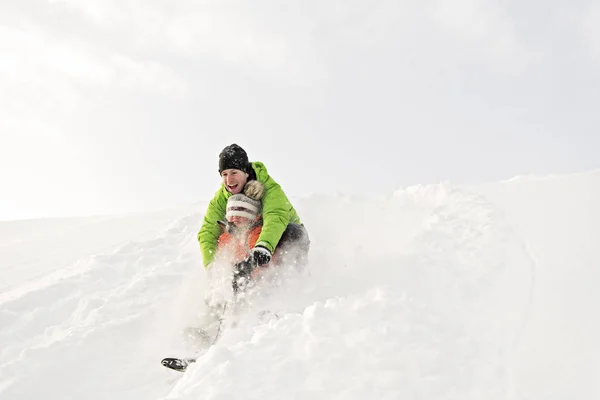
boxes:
[198,144,310,276]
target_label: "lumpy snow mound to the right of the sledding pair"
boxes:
[165,185,533,399]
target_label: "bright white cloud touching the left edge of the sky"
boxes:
[0,22,186,117]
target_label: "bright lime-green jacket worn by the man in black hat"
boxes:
[198,161,301,268]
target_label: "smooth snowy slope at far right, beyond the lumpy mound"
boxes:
[477,170,600,399]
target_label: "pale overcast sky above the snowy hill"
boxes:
[0,0,600,219]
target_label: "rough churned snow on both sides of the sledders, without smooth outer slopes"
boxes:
[0,185,534,400]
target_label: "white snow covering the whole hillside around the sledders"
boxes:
[0,171,600,400]
